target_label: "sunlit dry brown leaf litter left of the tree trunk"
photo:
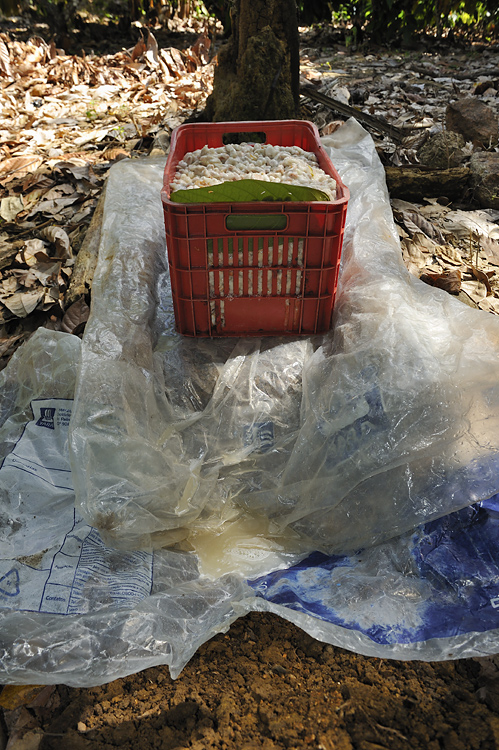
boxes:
[0,23,213,364]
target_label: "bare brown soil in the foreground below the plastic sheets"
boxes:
[0,613,499,750]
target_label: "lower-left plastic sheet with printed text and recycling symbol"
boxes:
[0,329,249,686]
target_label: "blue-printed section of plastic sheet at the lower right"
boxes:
[254,495,499,661]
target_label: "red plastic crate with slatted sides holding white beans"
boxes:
[161,120,349,336]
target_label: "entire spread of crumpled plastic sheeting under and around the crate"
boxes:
[0,120,499,687]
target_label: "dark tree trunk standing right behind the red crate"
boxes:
[205,0,300,122]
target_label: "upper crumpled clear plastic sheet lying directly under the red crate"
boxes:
[71,121,499,553]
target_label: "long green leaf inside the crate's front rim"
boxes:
[170,180,330,203]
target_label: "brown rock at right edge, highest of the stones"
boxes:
[445,96,499,148]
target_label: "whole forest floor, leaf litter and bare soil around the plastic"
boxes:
[0,11,499,750]
